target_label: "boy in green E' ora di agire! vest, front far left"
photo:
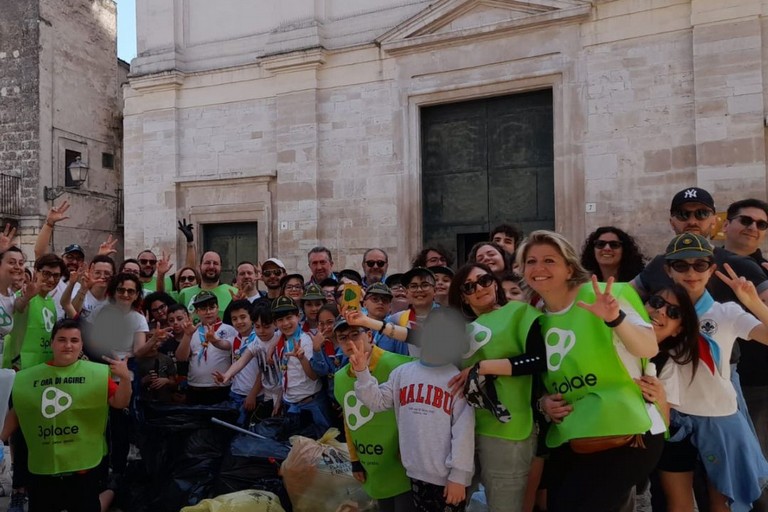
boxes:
[2,320,131,512]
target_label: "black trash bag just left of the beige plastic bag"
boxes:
[214,435,291,511]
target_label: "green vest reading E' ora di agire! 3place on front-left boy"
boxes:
[13,361,109,475]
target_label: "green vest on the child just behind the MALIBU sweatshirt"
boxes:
[333,348,413,499]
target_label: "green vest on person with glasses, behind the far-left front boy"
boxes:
[20,295,56,370]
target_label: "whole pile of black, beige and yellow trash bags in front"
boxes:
[117,404,377,512]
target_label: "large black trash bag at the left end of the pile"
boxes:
[118,404,239,512]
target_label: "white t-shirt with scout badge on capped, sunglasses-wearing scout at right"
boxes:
[675,302,760,416]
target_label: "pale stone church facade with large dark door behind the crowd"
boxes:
[124,0,768,273]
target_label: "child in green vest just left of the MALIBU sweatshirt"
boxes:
[333,317,415,512]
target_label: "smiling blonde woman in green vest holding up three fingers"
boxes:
[517,230,664,512]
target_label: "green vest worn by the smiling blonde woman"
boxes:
[540,283,651,448]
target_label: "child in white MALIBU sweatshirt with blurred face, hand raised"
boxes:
[349,309,475,512]
